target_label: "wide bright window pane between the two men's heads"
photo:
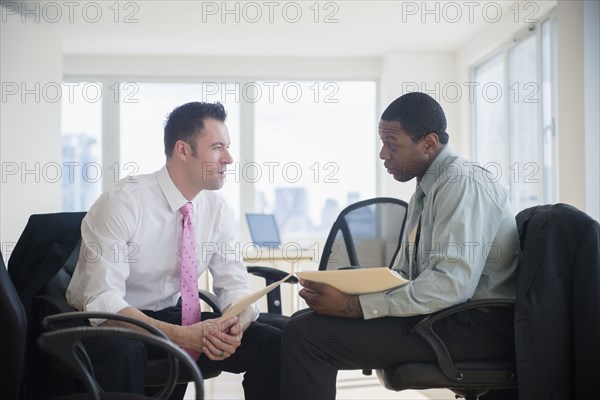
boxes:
[254,82,377,241]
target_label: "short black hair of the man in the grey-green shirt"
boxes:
[381,92,448,144]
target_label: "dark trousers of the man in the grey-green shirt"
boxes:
[281,310,514,399]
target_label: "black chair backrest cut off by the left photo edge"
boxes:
[0,253,27,400]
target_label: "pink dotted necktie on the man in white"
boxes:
[179,203,200,360]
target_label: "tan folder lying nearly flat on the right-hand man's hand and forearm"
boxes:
[296,267,408,294]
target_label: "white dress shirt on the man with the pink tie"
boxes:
[66,167,258,318]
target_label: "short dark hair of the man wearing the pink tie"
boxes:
[165,101,227,157]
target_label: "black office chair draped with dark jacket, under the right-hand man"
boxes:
[377,204,600,400]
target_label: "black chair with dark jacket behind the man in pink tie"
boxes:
[8,212,220,400]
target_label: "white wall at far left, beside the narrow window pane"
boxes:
[0,19,62,258]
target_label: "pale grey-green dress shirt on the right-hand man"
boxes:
[360,146,520,319]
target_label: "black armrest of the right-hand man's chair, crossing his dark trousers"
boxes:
[413,299,515,382]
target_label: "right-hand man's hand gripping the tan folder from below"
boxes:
[299,279,363,318]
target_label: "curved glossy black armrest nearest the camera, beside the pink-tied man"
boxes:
[38,324,204,400]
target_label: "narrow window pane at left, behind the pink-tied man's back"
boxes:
[61,82,103,211]
